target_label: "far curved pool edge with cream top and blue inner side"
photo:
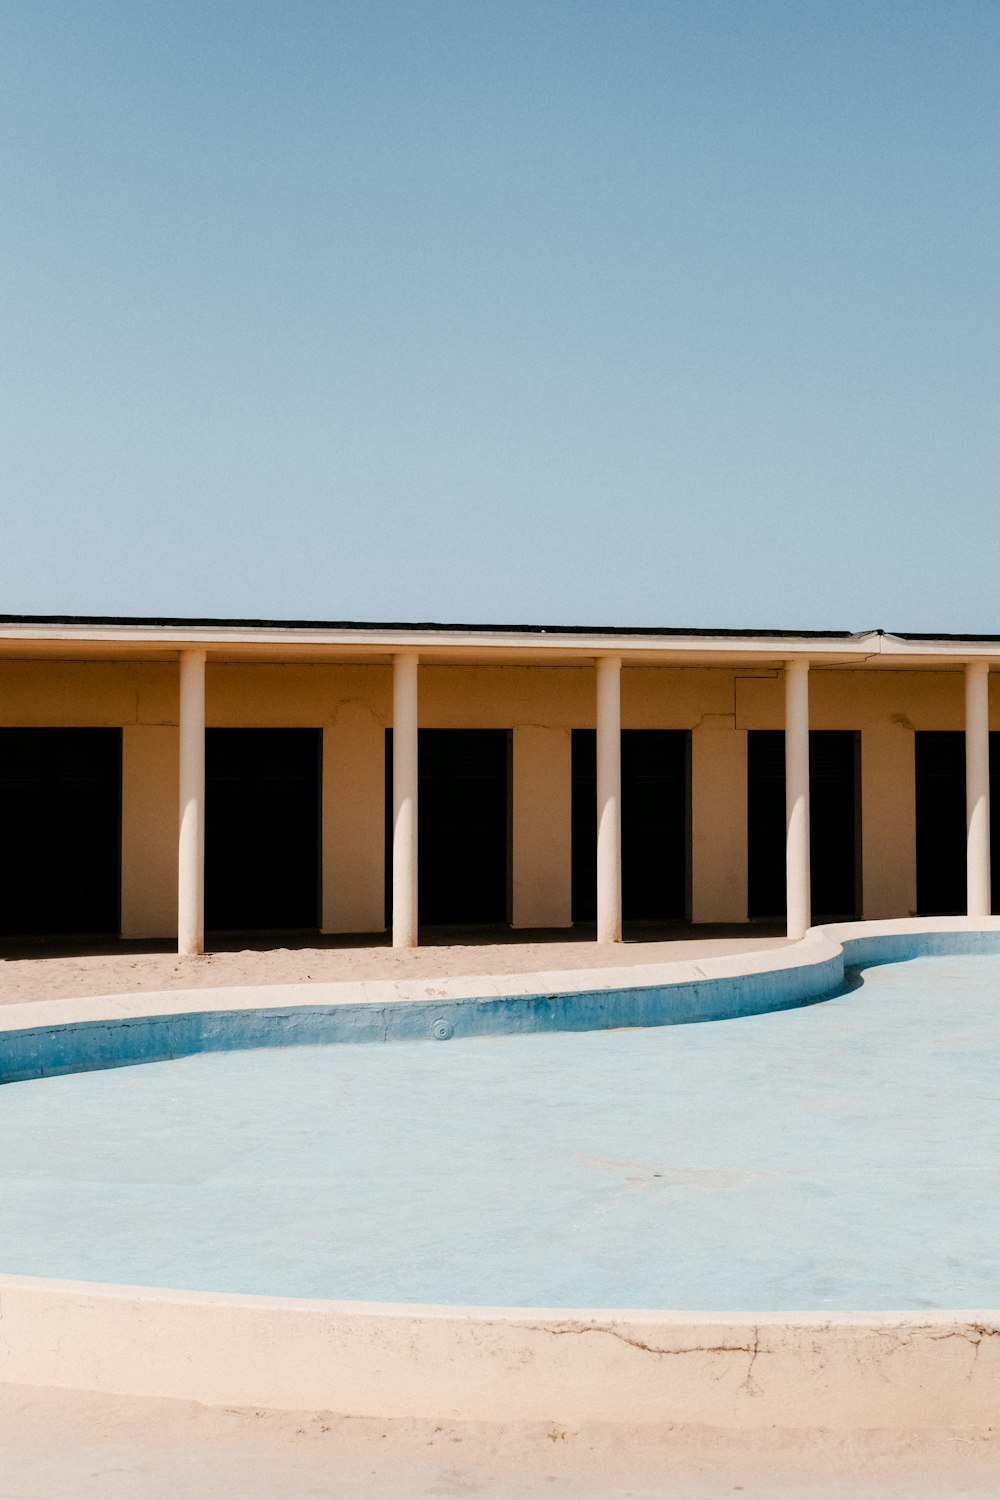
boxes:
[0,918,1000,1083]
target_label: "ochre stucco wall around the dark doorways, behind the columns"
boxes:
[0,660,1000,936]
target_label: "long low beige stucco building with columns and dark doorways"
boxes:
[0,617,1000,951]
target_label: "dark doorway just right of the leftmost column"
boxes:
[205,729,322,932]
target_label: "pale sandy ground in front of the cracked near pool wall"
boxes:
[0,1386,1000,1500]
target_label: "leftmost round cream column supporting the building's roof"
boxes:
[177,651,205,954]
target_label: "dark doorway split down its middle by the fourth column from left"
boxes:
[747,729,861,921]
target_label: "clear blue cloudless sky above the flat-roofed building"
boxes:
[0,0,1000,635]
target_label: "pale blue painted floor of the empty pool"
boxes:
[0,957,1000,1311]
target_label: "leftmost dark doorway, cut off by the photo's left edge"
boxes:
[0,729,121,936]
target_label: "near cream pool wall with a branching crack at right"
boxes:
[0,1277,1000,1431]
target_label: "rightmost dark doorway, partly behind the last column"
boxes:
[913,729,1000,917]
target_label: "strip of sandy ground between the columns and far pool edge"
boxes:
[0,929,786,1005]
